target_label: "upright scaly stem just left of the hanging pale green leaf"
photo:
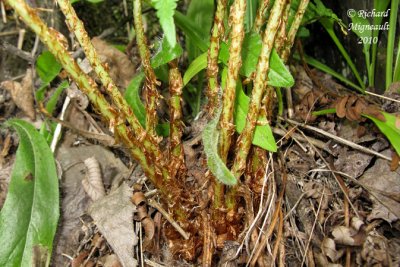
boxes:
[133,0,160,136]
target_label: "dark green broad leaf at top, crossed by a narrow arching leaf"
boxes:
[186,0,214,63]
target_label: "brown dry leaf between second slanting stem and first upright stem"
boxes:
[92,37,135,88]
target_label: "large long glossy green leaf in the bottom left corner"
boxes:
[0,120,59,266]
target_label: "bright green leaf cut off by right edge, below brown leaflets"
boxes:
[362,112,400,155]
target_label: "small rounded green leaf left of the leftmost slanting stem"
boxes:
[36,51,61,83]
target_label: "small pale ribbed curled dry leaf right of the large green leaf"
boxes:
[82,157,106,201]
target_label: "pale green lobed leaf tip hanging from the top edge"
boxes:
[151,0,178,47]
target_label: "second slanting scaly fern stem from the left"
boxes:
[57,0,162,173]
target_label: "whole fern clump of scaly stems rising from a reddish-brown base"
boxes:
[5,0,308,266]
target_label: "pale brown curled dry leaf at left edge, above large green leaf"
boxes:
[0,69,36,120]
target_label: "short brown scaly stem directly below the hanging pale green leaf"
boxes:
[169,60,185,177]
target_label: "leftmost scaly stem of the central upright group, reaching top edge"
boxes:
[206,0,227,116]
